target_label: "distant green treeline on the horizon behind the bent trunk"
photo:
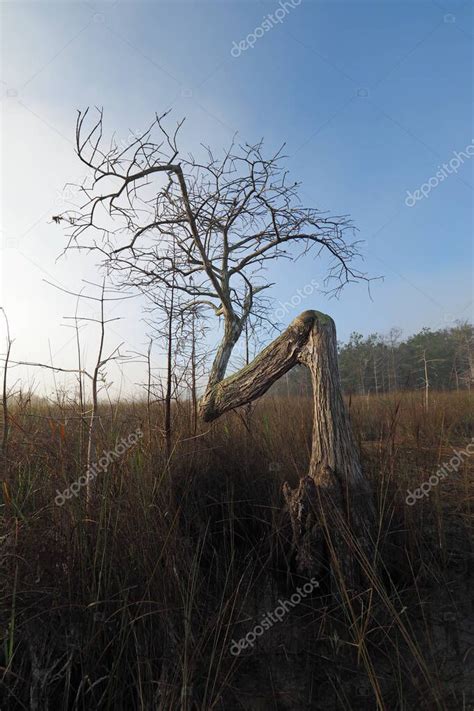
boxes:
[277,322,474,395]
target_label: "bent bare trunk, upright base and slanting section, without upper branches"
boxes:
[200,311,374,587]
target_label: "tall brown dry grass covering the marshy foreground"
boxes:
[0,392,474,711]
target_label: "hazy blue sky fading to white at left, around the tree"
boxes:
[0,0,474,394]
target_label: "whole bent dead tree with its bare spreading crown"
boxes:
[57,111,373,582]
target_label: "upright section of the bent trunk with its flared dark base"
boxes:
[284,312,374,586]
